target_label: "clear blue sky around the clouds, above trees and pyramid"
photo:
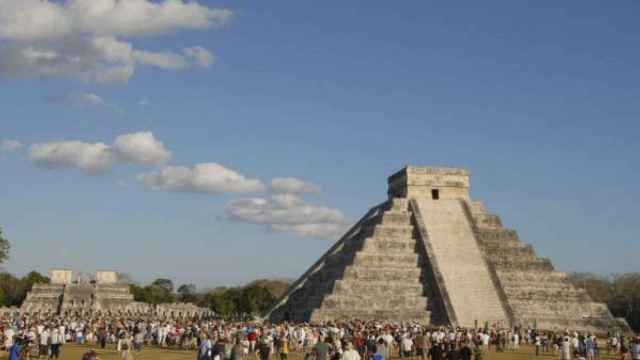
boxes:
[0,0,640,286]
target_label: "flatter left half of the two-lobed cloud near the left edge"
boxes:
[29,141,114,175]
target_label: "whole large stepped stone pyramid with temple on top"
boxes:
[267,167,627,333]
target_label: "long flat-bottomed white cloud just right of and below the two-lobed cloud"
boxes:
[138,163,265,193]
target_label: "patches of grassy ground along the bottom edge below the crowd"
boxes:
[0,345,617,360]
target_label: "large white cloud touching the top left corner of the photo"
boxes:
[0,0,233,41]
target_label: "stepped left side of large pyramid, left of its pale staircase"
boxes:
[268,199,430,322]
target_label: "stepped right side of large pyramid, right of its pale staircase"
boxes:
[466,201,629,333]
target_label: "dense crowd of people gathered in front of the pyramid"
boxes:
[0,315,640,360]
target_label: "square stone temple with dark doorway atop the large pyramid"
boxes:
[388,166,469,200]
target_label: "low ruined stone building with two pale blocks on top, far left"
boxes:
[20,269,211,318]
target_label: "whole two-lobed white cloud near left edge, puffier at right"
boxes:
[29,132,171,175]
